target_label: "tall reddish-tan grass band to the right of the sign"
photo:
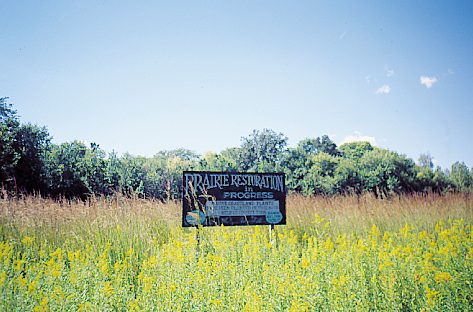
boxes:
[287,193,473,236]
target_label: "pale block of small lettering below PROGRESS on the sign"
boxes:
[205,200,279,218]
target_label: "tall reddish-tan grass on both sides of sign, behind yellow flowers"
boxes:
[0,193,473,254]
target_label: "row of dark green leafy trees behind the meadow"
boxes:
[0,97,473,199]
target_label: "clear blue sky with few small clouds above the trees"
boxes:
[0,0,473,169]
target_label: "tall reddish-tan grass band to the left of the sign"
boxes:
[0,195,181,254]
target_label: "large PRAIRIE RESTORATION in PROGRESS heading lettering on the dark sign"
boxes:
[184,172,284,199]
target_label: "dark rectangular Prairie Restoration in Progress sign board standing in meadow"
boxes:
[182,171,286,227]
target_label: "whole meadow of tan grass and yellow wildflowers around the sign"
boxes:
[0,193,473,311]
